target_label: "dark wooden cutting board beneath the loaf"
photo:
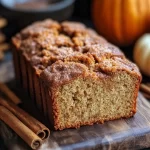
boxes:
[0,54,150,150]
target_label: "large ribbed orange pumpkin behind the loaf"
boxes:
[92,0,150,46]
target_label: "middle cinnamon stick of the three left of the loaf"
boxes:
[0,98,50,140]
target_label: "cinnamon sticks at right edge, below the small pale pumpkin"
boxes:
[140,83,150,99]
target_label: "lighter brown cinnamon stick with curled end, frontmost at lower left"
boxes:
[0,106,42,149]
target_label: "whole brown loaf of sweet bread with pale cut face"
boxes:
[12,19,141,130]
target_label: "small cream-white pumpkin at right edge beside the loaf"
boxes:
[133,34,150,76]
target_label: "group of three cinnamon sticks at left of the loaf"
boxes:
[0,83,50,149]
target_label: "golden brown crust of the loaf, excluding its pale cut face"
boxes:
[12,19,141,130]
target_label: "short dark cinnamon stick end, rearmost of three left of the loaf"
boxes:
[0,83,21,105]
